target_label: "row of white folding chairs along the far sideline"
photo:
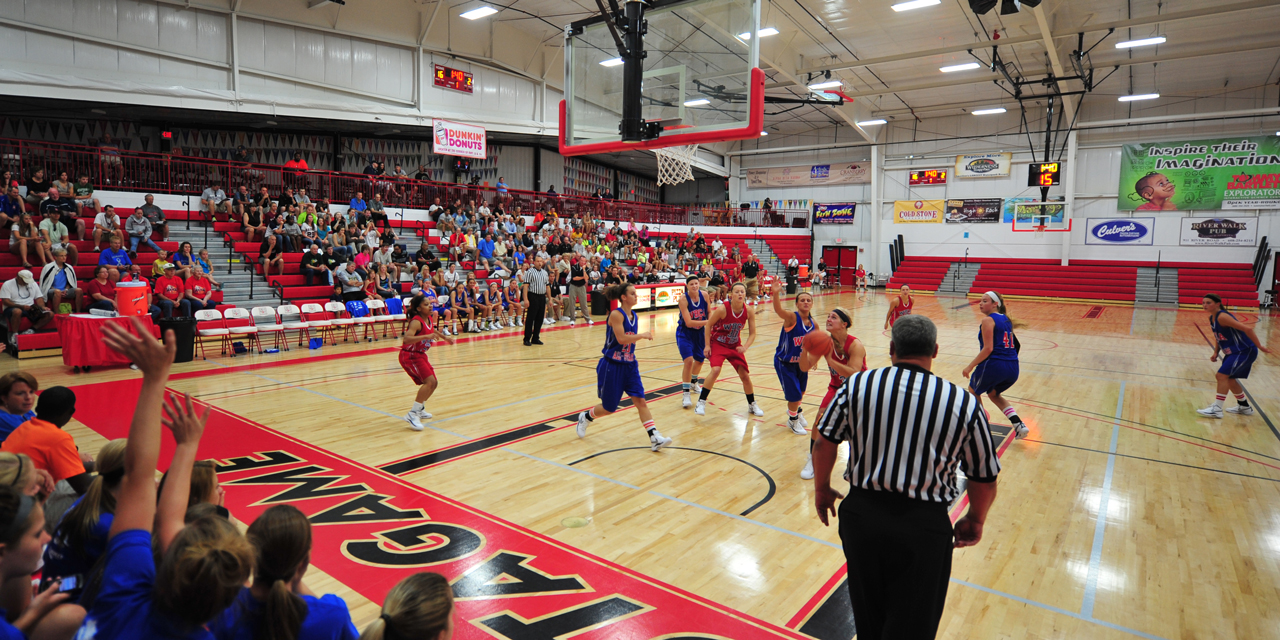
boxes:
[196,298,408,360]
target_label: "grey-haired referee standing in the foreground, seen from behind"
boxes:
[813,315,1000,640]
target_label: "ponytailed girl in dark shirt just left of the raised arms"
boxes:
[42,438,127,603]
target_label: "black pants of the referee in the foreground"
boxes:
[840,488,952,640]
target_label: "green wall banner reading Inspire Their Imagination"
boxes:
[1116,136,1280,211]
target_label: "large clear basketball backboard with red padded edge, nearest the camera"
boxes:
[559,0,764,156]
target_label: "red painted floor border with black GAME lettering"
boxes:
[67,380,805,640]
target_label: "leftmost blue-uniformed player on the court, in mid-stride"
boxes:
[577,283,671,451]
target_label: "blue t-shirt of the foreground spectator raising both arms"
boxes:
[76,529,214,640]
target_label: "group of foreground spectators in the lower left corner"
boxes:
[0,325,454,640]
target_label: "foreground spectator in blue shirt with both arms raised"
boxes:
[84,325,253,639]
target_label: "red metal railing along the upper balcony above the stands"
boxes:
[0,138,808,227]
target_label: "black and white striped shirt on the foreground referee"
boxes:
[818,364,1000,503]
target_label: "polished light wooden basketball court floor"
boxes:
[5,291,1280,639]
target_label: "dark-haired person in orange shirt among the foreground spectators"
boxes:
[0,387,93,495]
